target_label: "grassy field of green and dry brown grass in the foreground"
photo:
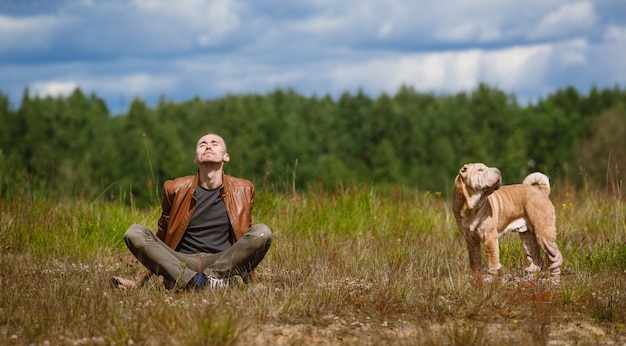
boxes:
[0,185,626,346]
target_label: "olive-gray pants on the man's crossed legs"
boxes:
[124,224,272,289]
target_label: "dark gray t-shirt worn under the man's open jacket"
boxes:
[176,186,234,253]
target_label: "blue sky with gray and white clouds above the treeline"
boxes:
[0,0,626,113]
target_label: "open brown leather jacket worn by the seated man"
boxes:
[156,174,254,249]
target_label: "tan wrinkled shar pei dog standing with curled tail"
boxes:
[452,163,563,283]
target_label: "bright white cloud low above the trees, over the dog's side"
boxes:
[330,45,553,93]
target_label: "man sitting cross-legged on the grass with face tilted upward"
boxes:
[112,133,272,289]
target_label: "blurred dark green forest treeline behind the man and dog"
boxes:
[0,84,626,203]
